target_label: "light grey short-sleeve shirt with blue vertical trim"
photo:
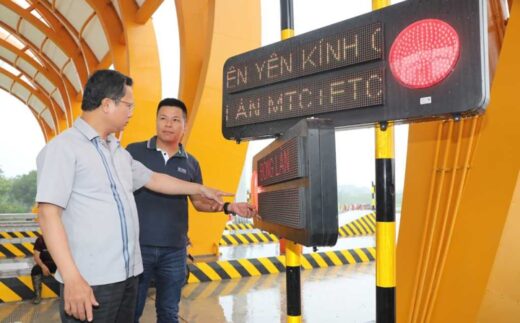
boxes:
[36,118,152,286]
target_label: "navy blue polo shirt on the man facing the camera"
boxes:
[126,136,202,249]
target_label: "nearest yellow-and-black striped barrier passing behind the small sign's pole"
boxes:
[188,247,376,283]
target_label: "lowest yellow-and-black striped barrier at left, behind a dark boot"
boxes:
[0,276,60,303]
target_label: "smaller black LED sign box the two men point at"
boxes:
[253,119,338,246]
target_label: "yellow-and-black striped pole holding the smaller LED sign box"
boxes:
[280,0,302,323]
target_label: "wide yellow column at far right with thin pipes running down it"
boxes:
[397,1,520,323]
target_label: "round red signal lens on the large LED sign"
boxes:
[388,19,460,89]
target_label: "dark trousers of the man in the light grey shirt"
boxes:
[60,277,138,323]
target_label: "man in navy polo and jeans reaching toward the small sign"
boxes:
[127,98,256,322]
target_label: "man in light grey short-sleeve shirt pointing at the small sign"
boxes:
[36,70,226,322]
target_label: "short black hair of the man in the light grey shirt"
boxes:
[81,70,134,111]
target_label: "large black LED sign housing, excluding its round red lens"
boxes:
[222,0,489,140]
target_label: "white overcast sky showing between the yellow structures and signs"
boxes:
[0,0,408,190]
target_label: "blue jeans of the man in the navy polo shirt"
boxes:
[135,246,186,323]
